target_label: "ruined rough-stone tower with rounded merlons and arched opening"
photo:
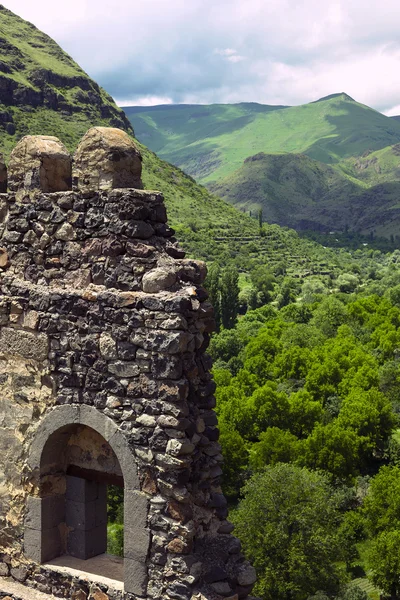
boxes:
[0,127,255,600]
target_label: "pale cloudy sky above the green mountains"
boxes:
[3,0,400,114]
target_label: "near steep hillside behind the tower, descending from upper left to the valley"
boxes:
[0,6,356,275]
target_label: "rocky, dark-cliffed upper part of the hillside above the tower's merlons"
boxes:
[0,5,133,154]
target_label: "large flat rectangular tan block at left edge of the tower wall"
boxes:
[0,327,49,361]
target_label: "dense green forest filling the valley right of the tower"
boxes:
[207,258,400,600]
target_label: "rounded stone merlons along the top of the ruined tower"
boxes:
[0,127,143,193]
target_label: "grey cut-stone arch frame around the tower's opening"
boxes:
[24,405,150,595]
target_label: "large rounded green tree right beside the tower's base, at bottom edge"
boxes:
[233,464,345,600]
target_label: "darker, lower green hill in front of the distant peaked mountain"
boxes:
[210,151,400,237]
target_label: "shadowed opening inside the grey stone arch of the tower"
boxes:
[39,424,124,582]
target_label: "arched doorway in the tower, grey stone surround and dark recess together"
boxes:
[24,406,150,594]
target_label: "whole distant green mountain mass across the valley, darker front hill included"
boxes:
[125,93,400,237]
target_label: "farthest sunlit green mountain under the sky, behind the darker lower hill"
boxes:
[125,94,400,184]
